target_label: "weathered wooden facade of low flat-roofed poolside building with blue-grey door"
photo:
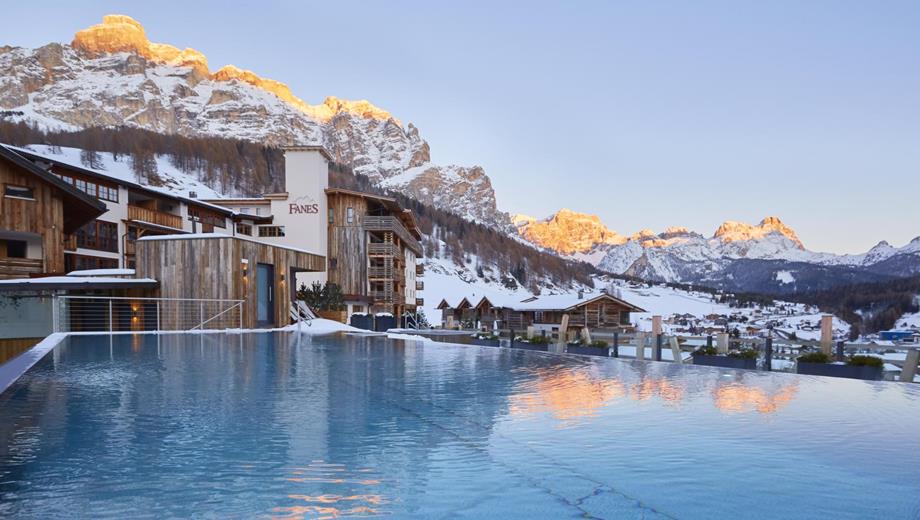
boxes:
[137,235,325,328]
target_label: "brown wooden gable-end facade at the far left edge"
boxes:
[0,145,105,279]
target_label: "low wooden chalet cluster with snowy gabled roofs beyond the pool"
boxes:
[439,292,645,333]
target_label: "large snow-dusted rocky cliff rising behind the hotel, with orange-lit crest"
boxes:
[0,15,510,229]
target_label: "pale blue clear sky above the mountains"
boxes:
[7,0,920,252]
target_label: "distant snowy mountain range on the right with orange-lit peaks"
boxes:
[514,210,920,294]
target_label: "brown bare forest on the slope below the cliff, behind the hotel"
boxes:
[0,120,596,292]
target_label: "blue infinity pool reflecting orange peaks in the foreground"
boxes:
[0,333,920,519]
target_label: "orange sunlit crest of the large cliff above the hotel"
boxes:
[71,14,392,126]
